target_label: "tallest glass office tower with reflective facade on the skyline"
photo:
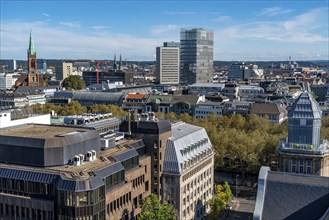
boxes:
[180,28,214,85]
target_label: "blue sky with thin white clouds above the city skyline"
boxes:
[0,0,329,61]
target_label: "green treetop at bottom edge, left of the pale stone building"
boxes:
[138,194,176,220]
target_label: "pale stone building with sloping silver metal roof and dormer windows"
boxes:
[162,122,214,220]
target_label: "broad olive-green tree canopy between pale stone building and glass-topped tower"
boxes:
[165,113,288,173]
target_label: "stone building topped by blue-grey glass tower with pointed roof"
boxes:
[278,92,329,177]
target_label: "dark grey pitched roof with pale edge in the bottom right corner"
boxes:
[255,167,329,220]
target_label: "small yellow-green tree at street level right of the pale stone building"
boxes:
[208,182,233,219]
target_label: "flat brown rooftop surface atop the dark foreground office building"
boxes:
[0,124,90,138]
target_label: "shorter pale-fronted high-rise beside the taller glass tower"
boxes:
[156,42,179,84]
